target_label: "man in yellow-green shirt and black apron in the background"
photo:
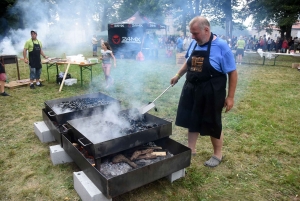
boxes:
[23,31,48,89]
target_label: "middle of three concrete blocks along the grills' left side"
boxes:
[50,145,73,165]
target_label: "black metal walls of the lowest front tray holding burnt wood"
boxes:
[62,132,191,199]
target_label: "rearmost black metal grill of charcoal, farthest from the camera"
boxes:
[42,92,120,145]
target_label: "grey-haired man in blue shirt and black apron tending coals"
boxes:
[170,16,237,167]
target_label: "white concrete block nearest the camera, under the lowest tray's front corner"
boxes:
[73,171,112,201]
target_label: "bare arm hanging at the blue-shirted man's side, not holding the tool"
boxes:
[224,70,237,112]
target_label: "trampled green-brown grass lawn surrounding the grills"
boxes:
[0,47,300,201]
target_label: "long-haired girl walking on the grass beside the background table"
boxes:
[100,42,117,88]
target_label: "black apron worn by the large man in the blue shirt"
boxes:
[175,33,227,139]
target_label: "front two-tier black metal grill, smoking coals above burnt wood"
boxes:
[62,109,191,198]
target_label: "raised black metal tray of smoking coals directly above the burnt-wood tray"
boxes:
[67,110,172,159]
